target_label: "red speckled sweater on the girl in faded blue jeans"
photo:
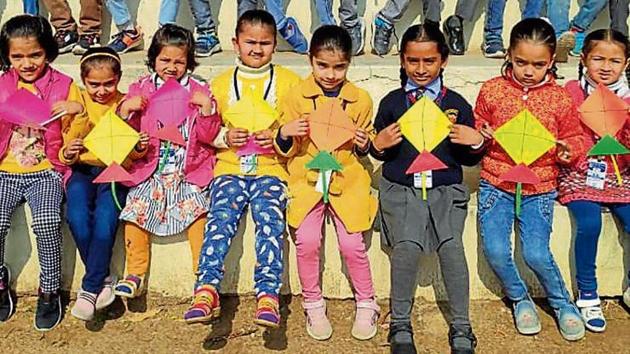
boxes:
[475,77,584,195]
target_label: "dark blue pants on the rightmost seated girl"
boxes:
[567,200,630,293]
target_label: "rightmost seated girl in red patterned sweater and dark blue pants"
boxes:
[558,29,630,332]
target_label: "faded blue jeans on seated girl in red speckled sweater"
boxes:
[477,180,571,310]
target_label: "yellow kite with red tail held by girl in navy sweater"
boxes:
[398,96,452,200]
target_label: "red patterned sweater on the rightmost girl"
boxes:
[558,80,630,204]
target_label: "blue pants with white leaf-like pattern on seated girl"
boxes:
[195,175,287,296]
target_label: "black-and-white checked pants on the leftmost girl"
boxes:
[0,170,63,292]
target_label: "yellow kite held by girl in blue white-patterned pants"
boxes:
[223,89,280,156]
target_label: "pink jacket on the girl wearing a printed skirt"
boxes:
[123,76,221,187]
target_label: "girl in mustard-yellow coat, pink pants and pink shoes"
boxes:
[276,25,380,340]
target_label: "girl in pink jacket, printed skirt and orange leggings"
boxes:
[114,24,220,298]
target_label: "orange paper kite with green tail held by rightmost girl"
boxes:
[579,84,630,185]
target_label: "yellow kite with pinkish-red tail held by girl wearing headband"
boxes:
[83,110,140,209]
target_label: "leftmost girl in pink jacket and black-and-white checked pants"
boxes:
[0,15,83,331]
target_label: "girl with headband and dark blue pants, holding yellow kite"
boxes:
[59,47,148,321]
